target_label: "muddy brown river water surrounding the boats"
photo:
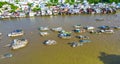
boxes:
[0,13,120,64]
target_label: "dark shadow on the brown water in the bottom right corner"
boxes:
[99,52,120,64]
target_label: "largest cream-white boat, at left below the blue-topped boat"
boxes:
[11,39,28,50]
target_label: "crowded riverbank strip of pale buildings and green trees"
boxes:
[0,0,120,19]
